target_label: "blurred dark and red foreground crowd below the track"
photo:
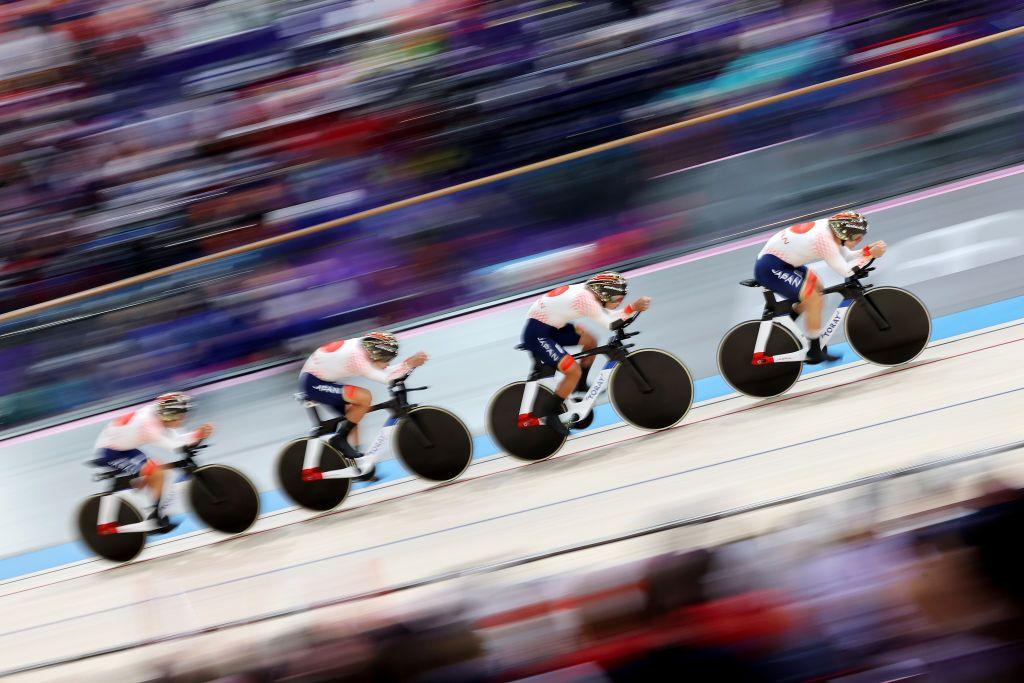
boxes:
[150,482,1024,683]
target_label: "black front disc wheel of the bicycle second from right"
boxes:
[608,348,693,429]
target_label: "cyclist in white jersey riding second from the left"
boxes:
[299,332,427,481]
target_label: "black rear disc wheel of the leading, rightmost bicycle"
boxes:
[718,321,804,398]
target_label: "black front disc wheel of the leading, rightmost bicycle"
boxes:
[846,287,932,366]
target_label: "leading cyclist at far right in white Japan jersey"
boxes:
[754,211,886,365]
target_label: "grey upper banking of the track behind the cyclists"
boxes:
[0,166,1024,557]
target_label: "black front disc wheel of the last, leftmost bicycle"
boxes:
[188,465,259,533]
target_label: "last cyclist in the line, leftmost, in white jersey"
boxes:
[92,391,213,533]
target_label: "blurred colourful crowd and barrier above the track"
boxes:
[0,0,1024,429]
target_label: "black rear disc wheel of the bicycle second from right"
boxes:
[487,382,565,461]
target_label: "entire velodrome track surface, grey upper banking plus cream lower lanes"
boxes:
[0,161,1024,680]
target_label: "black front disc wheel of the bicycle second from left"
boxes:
[394,405,473,481]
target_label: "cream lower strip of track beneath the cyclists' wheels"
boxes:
[0,318,1024,680]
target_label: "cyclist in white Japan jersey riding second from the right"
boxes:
[519,272,650,434]
